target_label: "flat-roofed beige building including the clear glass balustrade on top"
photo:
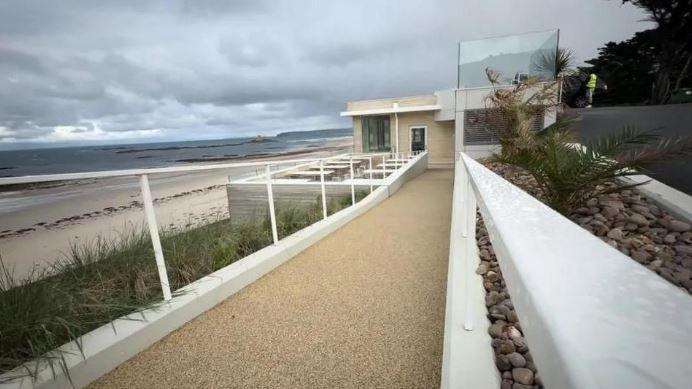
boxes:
[341,30,559,167]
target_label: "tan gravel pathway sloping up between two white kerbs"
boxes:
[91,170,453,388]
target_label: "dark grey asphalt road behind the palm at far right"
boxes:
[571,104,692,195]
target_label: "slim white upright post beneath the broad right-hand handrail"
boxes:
[463,166,476,331]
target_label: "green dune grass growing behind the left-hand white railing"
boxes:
[0,191,367,383]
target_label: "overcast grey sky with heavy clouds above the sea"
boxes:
[0,0,650,148]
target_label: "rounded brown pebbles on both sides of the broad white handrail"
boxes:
[476,161,692,389]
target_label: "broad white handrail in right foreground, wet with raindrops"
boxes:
[443,153,692,389]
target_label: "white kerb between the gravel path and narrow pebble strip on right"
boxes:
[440,158,500,389]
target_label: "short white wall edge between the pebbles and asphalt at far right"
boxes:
[620,174,692,223]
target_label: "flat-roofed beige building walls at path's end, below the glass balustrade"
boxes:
[341,85,555,168]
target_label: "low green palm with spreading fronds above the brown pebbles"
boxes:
[496,120,692,215]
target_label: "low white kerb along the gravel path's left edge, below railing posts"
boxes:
[0,186,389,389]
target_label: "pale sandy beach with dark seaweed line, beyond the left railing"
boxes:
[0,139,352,277]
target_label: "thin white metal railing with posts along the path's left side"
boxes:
[0,153,420,301]
